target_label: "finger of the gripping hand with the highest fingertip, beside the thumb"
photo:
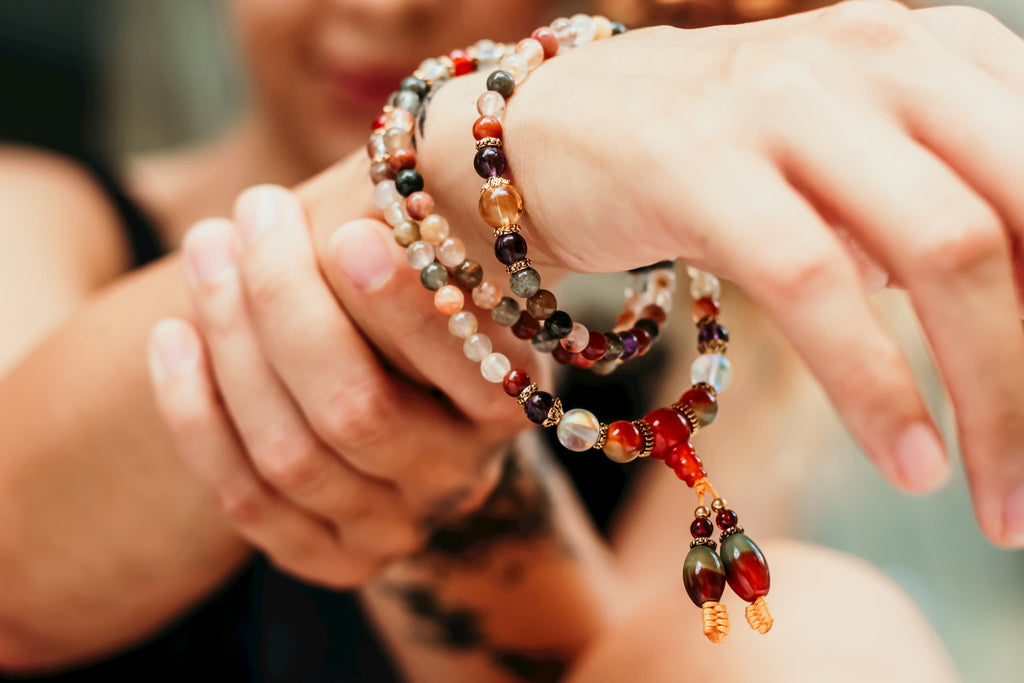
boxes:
[237,186,520,504]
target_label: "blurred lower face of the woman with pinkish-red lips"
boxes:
[231,0,555,167]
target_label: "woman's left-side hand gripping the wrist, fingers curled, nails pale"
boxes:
[151,186,540,587]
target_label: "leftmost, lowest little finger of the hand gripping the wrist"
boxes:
[148,319,376,586]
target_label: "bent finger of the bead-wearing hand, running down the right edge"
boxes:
[776,87,1024,545]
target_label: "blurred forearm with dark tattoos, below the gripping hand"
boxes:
[362,438,627,682]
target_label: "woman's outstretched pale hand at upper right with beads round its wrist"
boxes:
[420,0,1024,546]
